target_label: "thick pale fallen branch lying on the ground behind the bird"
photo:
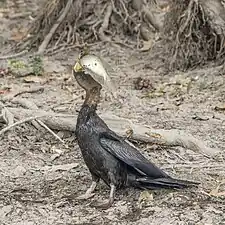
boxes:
[3,108,219,155]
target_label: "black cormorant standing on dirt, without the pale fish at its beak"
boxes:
[73,54,197,208]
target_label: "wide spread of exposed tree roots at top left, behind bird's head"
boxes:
[17,0,163,54]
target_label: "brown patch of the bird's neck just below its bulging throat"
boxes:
[83,87,101,109]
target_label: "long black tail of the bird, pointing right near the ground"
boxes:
[133,177,199,189]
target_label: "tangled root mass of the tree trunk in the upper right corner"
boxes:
[165,0,225,70]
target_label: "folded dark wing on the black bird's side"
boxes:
[100,132,169,178]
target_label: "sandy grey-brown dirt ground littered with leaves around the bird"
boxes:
[0,1,225,225]
